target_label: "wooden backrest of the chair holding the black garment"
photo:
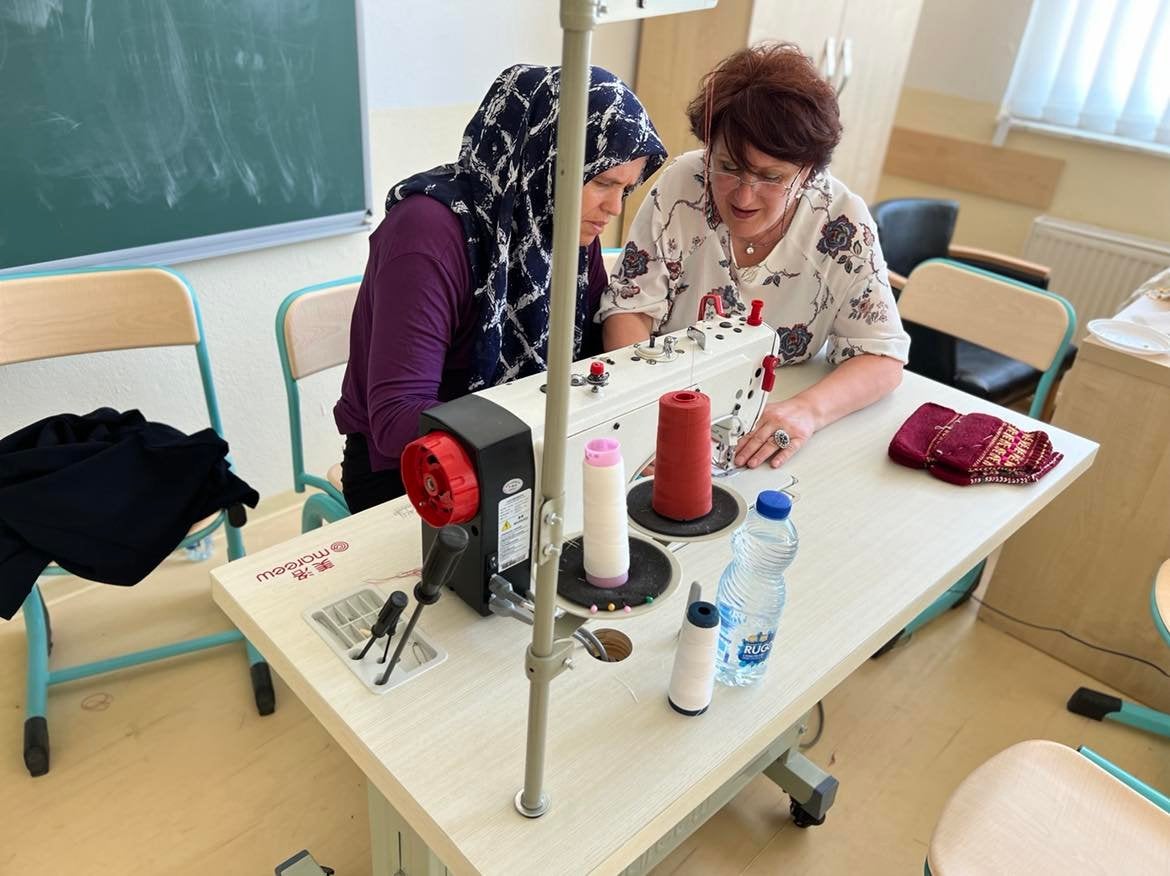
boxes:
[0,268,202,365]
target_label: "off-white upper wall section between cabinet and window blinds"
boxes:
[906,0,1032,103]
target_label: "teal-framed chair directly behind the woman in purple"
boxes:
[276,277,362,532]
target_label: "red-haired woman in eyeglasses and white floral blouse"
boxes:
[598,43,910,468]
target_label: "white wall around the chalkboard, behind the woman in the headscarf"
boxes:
[0,0,638,505]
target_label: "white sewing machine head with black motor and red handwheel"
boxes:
[402,302,777,615]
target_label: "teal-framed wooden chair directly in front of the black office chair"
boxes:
[874,258,1076,657]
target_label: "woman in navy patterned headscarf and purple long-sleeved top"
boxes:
[333,65,666,513]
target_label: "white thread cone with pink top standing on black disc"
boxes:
[581,439,629,589]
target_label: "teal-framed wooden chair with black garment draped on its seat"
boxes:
[0,268,276,775]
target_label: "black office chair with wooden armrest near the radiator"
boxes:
[872,198,1076,414]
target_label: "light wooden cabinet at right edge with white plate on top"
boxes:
[979,298,1170,710]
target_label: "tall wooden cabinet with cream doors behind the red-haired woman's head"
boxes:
[622,0,922,240]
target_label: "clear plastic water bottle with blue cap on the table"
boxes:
[715,490,797,687]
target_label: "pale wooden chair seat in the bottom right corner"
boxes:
[927,740,1170,876]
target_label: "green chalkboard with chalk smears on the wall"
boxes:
[0,0,370,269]
